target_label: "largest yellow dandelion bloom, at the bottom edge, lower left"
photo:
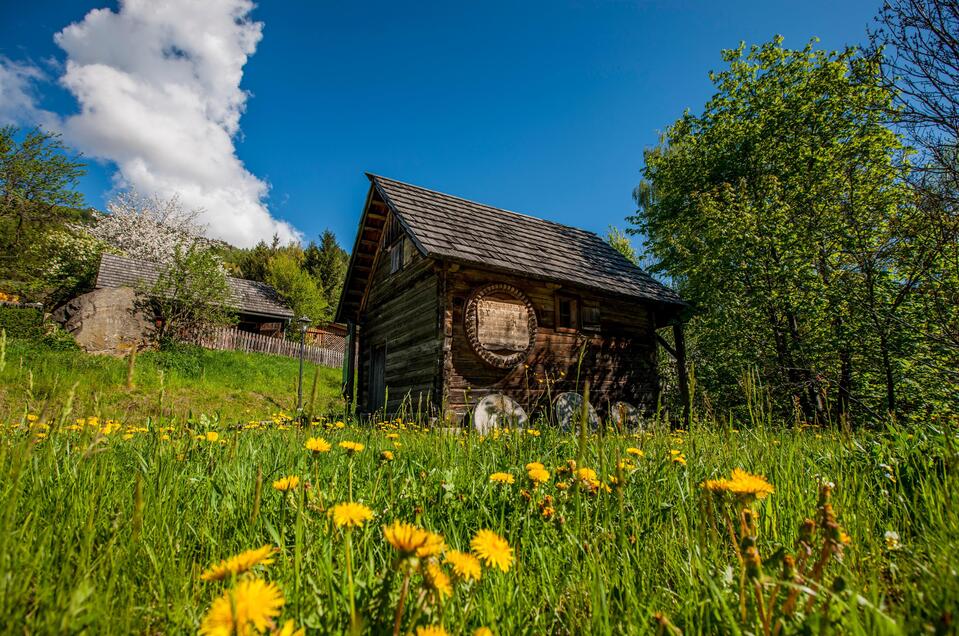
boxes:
[200,579,284,636]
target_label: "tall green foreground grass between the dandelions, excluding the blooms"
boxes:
[0,404,959,634]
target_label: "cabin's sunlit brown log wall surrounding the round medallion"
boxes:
[443,269,659,420]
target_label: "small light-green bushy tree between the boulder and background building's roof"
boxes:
[154,243,233,343]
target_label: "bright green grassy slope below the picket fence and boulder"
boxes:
[0,340,342,423]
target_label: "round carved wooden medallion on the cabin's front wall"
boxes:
[464,283,536,369]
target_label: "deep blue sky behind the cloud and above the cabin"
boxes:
[0,0,879,247]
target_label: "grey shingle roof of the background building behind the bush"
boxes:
[96,254,293,319]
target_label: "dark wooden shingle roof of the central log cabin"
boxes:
[367,174,685,305]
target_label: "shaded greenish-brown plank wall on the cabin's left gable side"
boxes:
[357,221,442,412]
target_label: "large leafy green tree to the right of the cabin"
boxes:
[632,38,956,421]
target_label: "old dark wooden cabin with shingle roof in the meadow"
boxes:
[336,175,686,416]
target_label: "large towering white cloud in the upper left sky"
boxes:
[50,0,299,246]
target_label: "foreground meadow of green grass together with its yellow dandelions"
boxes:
[0,332,959,635]
